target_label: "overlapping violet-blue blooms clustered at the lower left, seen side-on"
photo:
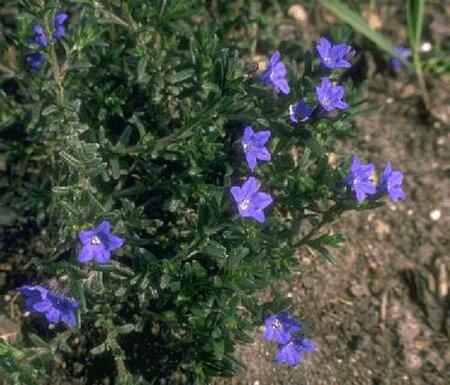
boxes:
[17,285,78,327]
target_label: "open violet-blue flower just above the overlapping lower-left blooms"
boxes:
[78,221,123,263]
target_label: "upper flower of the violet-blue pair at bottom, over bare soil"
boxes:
[262,311,302,344]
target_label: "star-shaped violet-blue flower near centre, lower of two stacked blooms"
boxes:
[230,176,273,223]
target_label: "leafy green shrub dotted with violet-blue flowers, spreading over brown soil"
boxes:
[0,1,405,384]
